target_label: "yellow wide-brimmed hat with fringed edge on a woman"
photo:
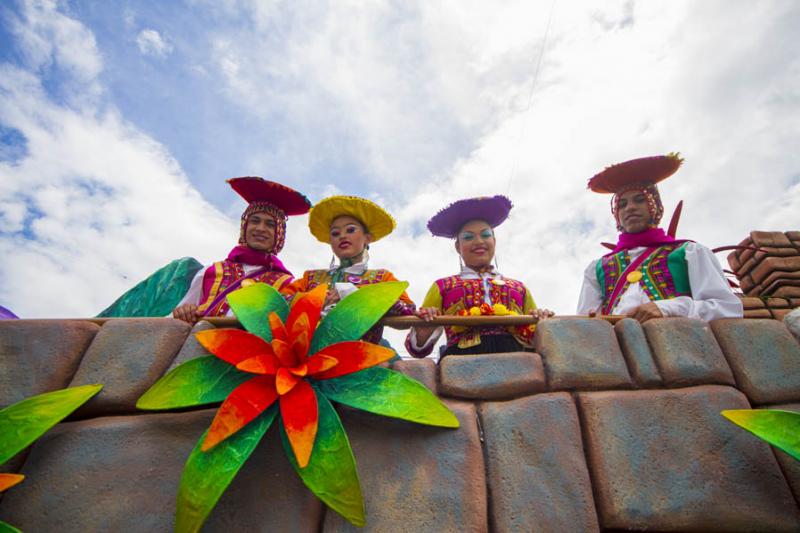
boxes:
[308,196,395,243]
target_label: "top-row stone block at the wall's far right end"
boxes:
[711,319,800,404]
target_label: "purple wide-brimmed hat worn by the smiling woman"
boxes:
[428,195,513,239]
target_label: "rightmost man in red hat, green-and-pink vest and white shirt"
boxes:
[578,154,742,322]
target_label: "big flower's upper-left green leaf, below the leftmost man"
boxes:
[225,283,289,342]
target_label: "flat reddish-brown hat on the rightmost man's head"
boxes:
[588,152,683,193]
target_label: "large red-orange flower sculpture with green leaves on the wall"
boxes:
[137,282,458,531]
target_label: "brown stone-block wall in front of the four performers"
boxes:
[0,318,800,532]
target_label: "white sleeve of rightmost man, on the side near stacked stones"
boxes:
[655,242,743,321]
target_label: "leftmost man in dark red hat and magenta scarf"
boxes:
[172,177,311,324]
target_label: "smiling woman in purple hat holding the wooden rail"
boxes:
[406,196,553,357]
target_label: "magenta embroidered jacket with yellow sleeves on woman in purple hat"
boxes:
[406,274,536,357]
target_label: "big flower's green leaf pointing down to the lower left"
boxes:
[175,405,278,532]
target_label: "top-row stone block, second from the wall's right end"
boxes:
[644,318,734,387]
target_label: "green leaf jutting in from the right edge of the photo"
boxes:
[722,409,800,461]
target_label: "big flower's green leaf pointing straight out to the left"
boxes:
[136,355,253,411]
